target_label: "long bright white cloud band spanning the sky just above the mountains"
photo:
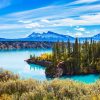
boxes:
[1,13,100,31]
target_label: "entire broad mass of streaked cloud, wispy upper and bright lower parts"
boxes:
[0,0,100,36]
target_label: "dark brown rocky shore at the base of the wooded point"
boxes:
[26,59,100,78]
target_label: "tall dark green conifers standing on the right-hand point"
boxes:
[52,38,100,74]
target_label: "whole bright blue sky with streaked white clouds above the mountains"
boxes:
[0,0,100,38]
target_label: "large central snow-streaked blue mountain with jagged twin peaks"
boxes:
[26,31,74,41]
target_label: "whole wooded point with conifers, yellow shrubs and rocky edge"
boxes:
[27,38,100,77]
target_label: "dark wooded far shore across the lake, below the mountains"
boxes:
[0,41,53,50]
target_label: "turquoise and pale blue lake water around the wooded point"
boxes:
[0,49,100,83]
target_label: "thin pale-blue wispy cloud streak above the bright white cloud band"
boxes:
[3,4,100,22]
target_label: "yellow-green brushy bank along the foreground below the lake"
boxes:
[0,69,100,100]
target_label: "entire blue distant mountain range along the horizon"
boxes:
[0,31,100,42]
